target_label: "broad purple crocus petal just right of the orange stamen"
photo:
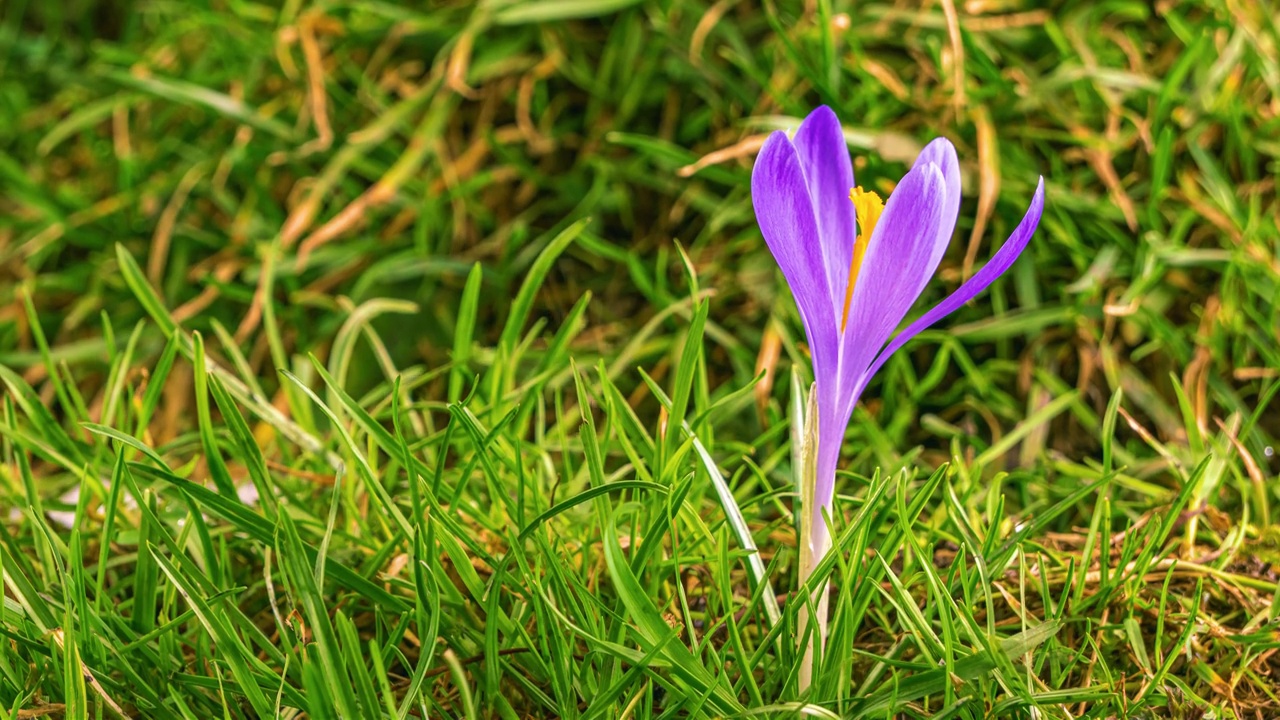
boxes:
[840,163,947,412]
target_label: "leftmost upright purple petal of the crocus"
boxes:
[751,131,847,392]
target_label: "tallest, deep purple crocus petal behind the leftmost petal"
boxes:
[792,105,860,316]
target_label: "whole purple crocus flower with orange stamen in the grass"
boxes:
[751,106,1044,580]
